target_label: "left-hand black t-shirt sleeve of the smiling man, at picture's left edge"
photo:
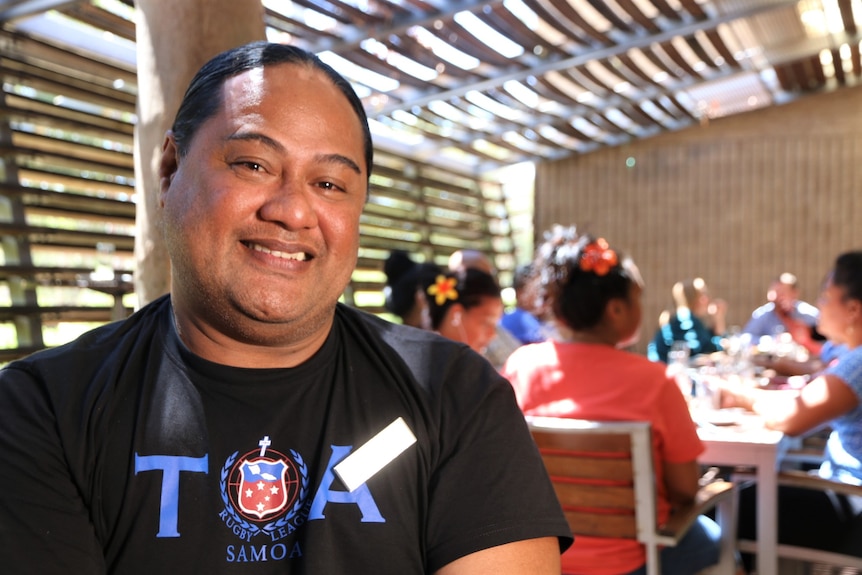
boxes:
[0,367,105,575]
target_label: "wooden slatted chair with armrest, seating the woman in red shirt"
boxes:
[527,417,737,575]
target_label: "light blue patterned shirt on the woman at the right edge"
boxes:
[820,347,862,485]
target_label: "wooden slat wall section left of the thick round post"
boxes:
[0,32,136,362]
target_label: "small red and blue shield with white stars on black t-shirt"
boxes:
[236,457,287,519]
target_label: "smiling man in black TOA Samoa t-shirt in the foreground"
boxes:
[0,43,570,575]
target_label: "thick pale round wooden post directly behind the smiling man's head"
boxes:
[135,0,266,305]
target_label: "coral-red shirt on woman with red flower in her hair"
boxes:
[503,341,704,575]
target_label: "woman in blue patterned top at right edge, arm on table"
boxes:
[721,251,862,568]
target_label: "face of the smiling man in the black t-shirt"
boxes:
[160,64,368,344]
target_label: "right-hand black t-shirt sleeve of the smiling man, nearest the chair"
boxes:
[427,355,571,571]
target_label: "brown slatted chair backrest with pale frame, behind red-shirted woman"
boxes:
[527,417,659,544]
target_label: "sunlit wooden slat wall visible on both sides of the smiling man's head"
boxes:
[0,31,514,363]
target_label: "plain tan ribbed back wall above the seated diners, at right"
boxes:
[535,88,862,352]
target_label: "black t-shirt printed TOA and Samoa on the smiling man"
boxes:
[0,297,570,575]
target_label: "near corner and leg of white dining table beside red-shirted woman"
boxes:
[692,407,795,575]
